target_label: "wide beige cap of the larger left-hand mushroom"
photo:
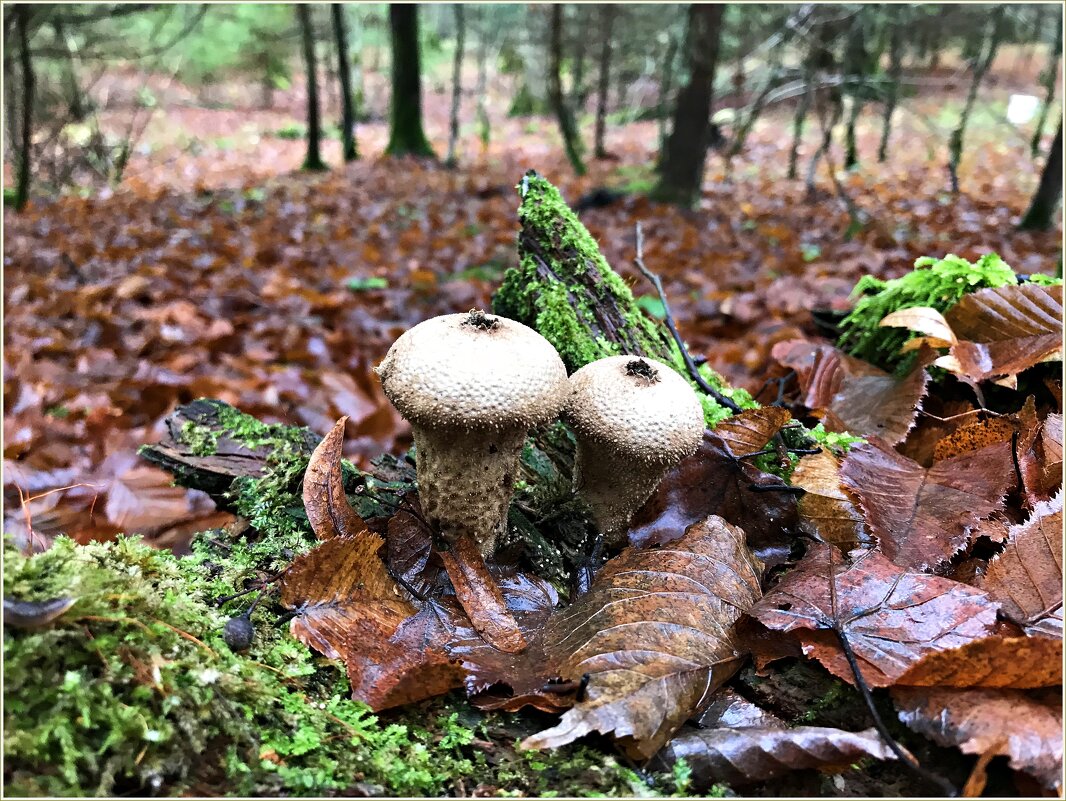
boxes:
[377,311,566,430]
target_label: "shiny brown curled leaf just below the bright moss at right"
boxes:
[773,339,932,445]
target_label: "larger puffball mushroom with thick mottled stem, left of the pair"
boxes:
[377,310,566,556]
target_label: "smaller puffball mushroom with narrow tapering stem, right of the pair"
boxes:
[563,356,704,545]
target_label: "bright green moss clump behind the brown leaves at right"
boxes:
[839,253,1018,371]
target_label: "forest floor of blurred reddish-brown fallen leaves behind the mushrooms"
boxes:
[4,64,1061,542]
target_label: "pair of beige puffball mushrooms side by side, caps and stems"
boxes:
[377,310,704,556]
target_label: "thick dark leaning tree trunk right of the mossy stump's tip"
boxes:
[651,3,725,207]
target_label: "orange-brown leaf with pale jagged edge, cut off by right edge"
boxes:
[979,493,1063,639]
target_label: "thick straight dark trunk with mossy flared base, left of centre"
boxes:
[385,3,434,158]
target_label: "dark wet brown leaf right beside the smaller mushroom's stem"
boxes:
[629,426,796,564]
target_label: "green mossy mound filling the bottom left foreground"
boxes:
[4,538,695,796]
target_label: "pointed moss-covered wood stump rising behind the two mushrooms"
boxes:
[492,173,758,427]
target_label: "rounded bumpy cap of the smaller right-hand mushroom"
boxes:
[563,356,704,464]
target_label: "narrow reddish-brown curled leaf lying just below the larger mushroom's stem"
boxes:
[440,534,527,654]
